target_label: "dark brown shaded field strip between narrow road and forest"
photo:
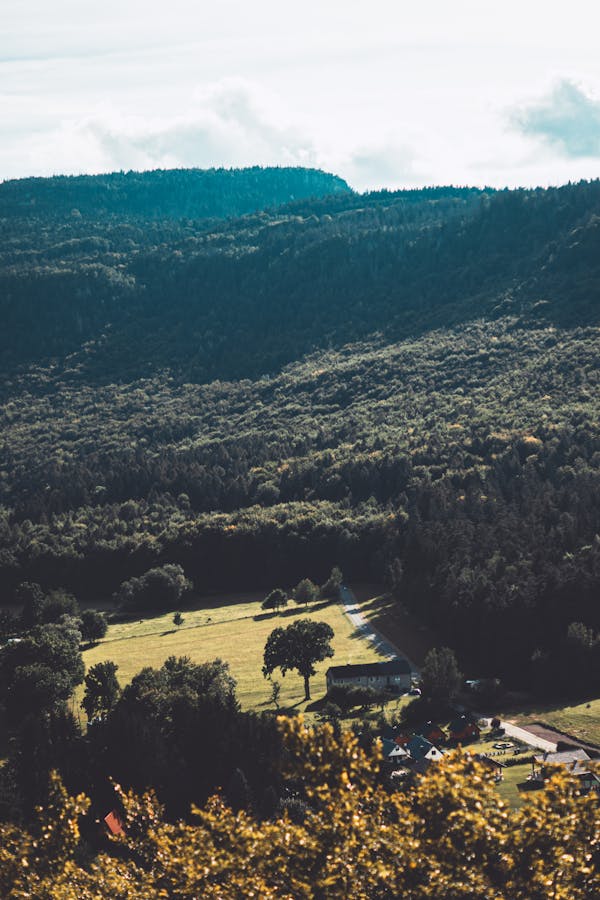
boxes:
[352,584,439,668]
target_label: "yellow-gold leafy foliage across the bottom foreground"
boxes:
[0,719,600,900]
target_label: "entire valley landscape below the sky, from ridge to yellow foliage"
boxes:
[0,167,600,900]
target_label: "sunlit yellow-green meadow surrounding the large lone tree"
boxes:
[83,594,381,710]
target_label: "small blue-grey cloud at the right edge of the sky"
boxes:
[512,79,600,158]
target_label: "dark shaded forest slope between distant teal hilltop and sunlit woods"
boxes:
[0,178,600,383]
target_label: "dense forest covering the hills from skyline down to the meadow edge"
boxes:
[0,163,600,680]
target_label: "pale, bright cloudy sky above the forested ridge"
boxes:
[0,0,600,190]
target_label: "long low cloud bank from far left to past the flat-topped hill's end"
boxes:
[0,78,423,190]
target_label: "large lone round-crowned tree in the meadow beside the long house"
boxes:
[263,619,333,700]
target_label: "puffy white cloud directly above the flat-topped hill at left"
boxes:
[0,79,317,174]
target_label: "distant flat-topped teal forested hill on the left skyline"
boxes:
[0,166,350,221]
